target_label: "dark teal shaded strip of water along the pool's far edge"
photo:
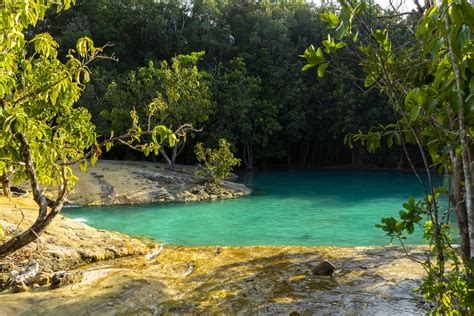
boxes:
[238,169,444,203]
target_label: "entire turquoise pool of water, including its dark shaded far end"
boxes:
[64,170,444,246]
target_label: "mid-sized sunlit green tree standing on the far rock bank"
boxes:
[101,52,211,168]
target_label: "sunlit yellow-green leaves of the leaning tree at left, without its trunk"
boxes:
[0,1,98,188]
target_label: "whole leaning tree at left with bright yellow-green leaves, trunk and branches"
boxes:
[0,0,178,256]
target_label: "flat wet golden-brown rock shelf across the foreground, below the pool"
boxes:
[0,238,426,315]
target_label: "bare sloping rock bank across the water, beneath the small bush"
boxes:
[65,160,252,205]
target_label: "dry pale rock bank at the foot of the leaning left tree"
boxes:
[0,197,149,291]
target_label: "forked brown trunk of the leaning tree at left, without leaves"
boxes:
[0,133,68,257]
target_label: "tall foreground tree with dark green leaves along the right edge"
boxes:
[304,0,474,314]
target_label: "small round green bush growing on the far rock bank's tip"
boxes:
[194,138,240,183]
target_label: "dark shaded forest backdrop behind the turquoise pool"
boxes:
[35,0,410,167]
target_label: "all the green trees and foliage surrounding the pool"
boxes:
[0,0,474,315]
